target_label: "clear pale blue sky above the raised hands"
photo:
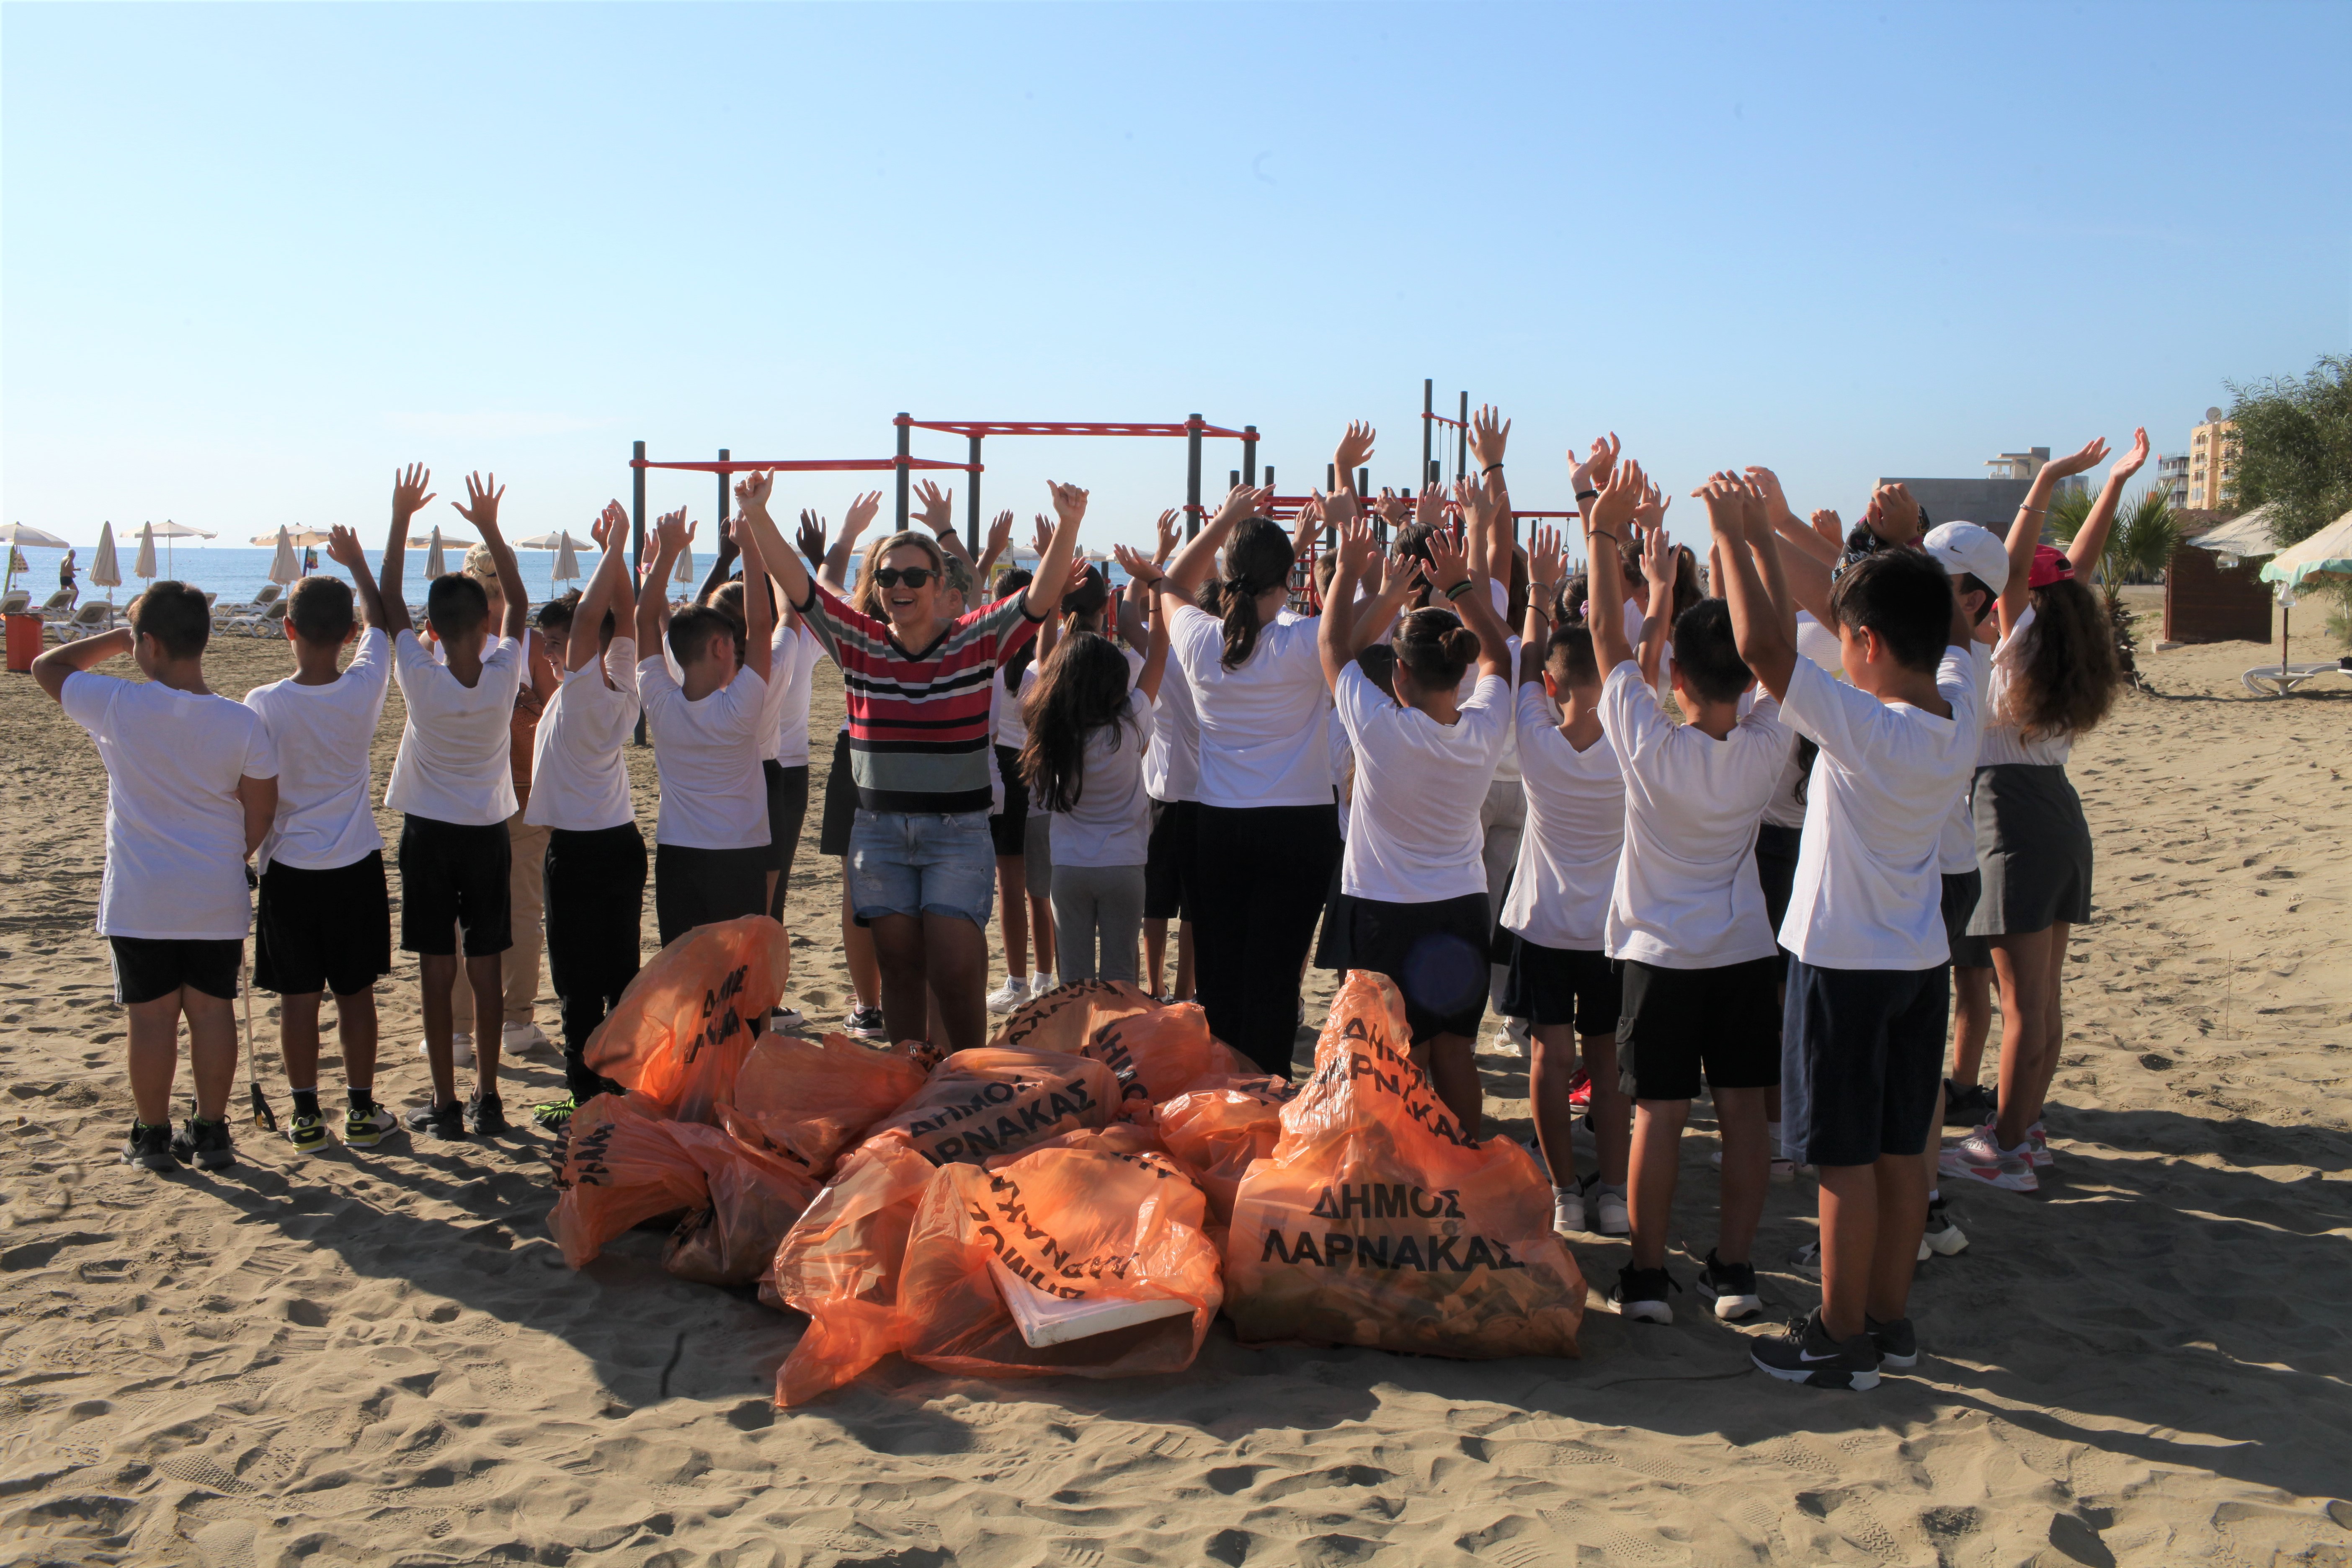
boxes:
[0,3,2352,545]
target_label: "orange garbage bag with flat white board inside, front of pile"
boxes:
[898,1150,1223,1377]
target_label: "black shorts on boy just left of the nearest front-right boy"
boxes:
[1618,959,1795,1100]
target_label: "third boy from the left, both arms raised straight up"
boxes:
[381,463,524,1138]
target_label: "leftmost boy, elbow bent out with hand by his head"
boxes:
[33,580,278,1171]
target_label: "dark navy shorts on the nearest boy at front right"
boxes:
[1780,959,1952,1166]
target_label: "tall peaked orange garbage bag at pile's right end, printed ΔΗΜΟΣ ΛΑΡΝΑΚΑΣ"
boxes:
[1225,969,1585,1357]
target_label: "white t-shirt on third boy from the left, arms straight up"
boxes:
[383,632,522,828]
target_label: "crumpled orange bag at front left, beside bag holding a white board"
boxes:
[762,1140,931,1408]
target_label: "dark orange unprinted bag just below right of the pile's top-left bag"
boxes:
[720,1034,929,1178]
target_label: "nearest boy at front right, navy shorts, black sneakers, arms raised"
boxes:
[1700,475,1978,1389]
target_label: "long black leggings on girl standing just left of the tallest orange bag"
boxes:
[1185,806,1341,1077]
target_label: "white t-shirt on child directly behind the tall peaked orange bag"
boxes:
[1331,660,1510,903]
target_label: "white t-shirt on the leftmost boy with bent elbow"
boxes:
[59,670,278,943]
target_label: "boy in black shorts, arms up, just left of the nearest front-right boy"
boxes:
[1588,461,1787,1323]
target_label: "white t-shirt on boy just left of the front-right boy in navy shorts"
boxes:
[1602,658,1778,969]
